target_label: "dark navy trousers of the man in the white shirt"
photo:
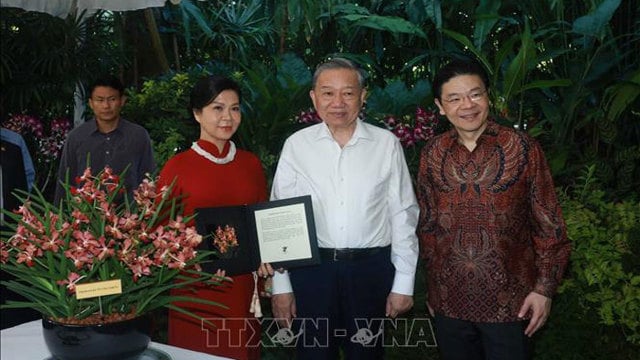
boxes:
[290,248,395,360]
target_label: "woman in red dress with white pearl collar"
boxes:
[160,76,267,359]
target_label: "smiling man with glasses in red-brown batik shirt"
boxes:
[417,60,570,360]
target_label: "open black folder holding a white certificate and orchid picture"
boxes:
[196,195,320,275]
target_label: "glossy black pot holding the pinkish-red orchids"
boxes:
[42,316,151,360]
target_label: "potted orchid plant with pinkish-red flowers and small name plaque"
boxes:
[0,167,223,359]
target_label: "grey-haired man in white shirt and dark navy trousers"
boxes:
[271,58,419,360]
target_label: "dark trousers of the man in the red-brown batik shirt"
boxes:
[435,314,532,360]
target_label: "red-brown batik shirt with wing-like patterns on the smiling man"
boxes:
[417,122,570,322]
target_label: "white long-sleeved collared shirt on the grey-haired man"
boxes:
[271,120,419,295]
